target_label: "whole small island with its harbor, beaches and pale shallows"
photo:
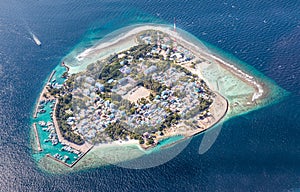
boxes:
[32,24,284,172]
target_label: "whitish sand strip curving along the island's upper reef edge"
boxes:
[66,24,268,102]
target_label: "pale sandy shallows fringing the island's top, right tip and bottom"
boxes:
[39,24,286,173]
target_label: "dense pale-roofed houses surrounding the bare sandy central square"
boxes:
[58,30,210,142]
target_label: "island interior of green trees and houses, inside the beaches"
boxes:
[45,31,215,147]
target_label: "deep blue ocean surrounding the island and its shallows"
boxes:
[0,0,300,192]
